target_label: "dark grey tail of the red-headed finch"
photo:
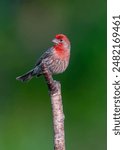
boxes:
[16,69,35,82]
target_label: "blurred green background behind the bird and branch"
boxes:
[0,0,106,150]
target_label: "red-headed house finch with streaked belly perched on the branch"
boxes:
[16,34,70,81]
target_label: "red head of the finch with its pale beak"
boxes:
[52,34,70,49]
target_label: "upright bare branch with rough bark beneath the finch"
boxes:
[42,63,65,150]
